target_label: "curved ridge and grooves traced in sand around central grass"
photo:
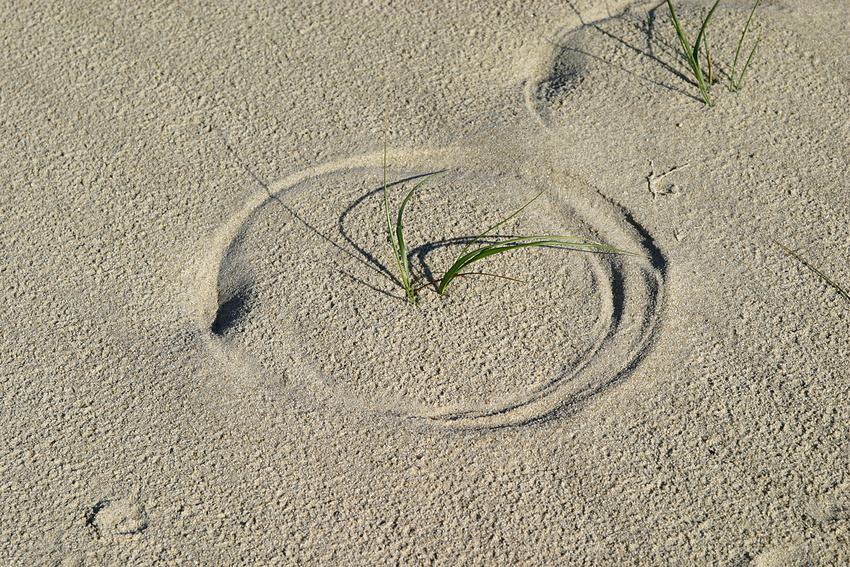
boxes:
[194,148,664,428]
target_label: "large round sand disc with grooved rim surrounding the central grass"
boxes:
[194,156,662,427]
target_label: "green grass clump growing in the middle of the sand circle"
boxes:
[384,148,638,304]
